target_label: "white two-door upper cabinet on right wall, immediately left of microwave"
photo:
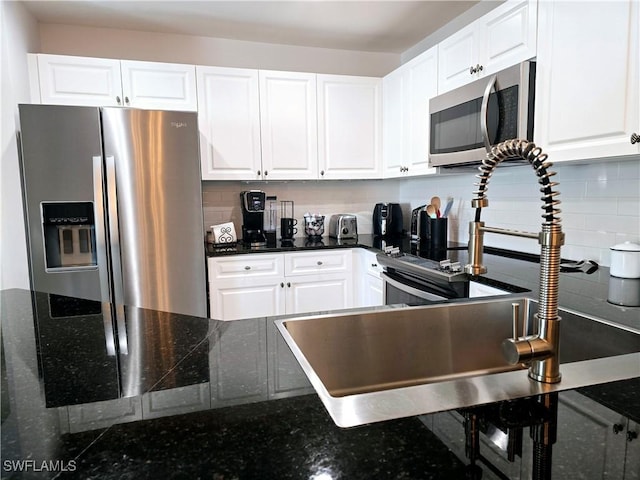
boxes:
[383,47,438,178]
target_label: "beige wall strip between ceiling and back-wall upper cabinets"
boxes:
[39,24,400,76]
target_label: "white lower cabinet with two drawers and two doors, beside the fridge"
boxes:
[208,249,354,320]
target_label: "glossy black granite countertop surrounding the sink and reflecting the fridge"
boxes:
[0,239,640,479]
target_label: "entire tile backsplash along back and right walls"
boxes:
[202,159,640,265]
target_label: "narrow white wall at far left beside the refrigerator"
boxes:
[0,1,39,289]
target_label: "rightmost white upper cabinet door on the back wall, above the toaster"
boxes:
[317,75,382,179]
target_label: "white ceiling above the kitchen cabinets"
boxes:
[24,0,479,53]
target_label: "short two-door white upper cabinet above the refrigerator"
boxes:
[29,54,197,111]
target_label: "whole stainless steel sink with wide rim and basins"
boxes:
[276,297,640,426]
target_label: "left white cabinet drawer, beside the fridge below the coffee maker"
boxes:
[209,253,284,281]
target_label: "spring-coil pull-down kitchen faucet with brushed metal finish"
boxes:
[465,139,564,383]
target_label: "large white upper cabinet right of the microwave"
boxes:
[534,0,640,162]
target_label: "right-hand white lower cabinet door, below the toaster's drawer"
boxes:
[286,274,353,313]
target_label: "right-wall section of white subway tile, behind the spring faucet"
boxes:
[400,158,640,265]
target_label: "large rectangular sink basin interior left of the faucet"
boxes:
[284,300,524,397]
